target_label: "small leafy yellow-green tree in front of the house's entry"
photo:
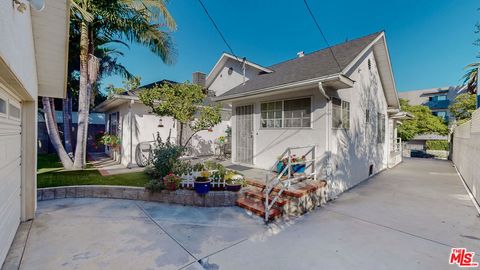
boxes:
[140,82,222,146]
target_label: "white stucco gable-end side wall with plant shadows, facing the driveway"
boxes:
[331,52,390,194]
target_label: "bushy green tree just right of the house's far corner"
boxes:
[398,99,448,141]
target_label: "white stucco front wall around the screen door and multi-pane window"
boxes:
[232,89,326,169]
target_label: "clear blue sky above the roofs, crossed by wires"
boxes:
[102,0,480,91]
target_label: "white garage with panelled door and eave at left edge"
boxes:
[0,0,70,265]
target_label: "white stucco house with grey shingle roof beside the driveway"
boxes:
[206,32,405,194]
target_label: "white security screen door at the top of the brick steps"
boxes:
[235,105,253,164]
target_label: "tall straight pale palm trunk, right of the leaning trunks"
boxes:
[73,22,91,169]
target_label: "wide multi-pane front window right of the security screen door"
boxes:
[260,98,311,128]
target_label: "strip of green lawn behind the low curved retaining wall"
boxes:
[37,154,149,188]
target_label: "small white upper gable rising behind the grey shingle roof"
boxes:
[208,59,259,96]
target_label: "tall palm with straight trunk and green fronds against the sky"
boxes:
[72,0,176,169]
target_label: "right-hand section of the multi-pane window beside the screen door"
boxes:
[284,98,310,127]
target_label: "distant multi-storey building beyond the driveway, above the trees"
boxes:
[399,86,467,122]
